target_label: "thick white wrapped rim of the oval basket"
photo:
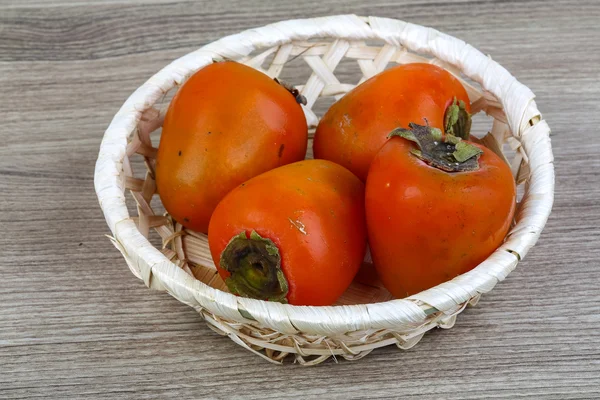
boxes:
[94,15,554,334]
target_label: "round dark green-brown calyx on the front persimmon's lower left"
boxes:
[219,231,288,303]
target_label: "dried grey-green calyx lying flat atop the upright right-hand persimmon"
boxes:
[388,122,483,172]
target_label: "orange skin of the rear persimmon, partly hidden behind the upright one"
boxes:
[313,63,470,181]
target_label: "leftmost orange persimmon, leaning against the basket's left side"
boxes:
[156,61,308,232]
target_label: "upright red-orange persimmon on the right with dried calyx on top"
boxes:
[365,124,516,298]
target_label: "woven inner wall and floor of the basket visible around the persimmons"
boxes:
[123,39,529,305]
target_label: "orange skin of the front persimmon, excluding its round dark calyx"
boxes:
[208,160,367,306]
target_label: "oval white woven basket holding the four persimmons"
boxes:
[95,15,554,365]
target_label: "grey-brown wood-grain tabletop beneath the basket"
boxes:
[0,0,600,399]
